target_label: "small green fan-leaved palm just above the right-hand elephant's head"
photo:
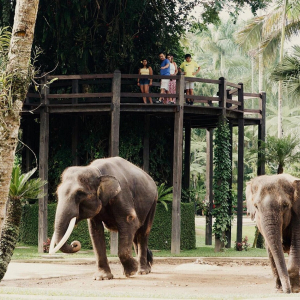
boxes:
[255,134,300,174]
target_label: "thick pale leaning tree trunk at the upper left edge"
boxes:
[0,0,39,237]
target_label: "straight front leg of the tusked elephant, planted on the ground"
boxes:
[88,217,113,280]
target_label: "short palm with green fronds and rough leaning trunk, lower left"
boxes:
[0,166,46,280]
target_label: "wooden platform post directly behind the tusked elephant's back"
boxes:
[109,70,121,255]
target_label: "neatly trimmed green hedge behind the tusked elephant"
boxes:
[19,203,196,250]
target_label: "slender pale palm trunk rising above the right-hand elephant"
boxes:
[277,0,288,138]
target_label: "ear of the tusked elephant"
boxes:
[97,175,121,206]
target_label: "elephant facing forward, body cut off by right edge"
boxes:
[246,174,300,293]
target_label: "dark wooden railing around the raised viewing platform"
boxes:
[25,71,266,119]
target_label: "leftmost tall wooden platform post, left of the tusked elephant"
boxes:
[38,76,49,253]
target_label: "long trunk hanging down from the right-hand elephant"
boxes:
[262,215,291,293]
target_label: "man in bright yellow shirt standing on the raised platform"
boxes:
[179,54,200,105]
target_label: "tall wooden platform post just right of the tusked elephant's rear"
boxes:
[171,75,184,254]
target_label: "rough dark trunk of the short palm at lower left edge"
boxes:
[0,199,22,281]
